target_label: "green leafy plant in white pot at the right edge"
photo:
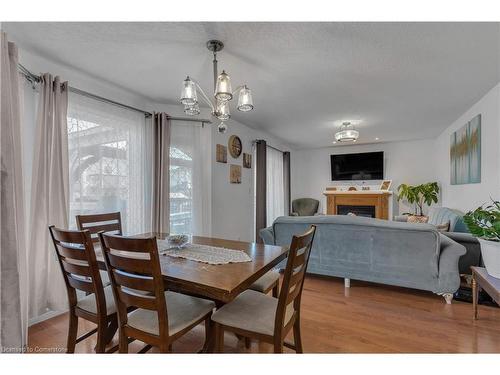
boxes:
[464,200,500,278]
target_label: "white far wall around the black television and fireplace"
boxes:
[291,140,437,215]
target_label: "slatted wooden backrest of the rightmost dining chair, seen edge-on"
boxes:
[274,225,316,333]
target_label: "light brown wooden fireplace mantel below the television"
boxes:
[323,189,392,220]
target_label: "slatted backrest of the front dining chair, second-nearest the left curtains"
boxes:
[99,232,168,337]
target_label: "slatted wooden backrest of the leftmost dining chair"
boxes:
[49,225,107,316]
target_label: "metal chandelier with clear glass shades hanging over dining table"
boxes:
[181,40,253,133]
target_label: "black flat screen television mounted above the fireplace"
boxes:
[330,151,384,181]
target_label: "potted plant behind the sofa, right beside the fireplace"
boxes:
[398,182,439,222]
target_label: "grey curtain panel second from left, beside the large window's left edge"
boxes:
[28,74,69,318]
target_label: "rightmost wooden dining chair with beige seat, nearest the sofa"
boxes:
[212,225,316,353]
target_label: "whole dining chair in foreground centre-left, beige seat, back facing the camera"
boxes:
[99,232,215,353]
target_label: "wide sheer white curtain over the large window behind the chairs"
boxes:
[68,93,152,234]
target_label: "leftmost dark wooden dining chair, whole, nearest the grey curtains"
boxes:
[49,225,118,353]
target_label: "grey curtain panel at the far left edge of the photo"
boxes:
[0,32,28,353]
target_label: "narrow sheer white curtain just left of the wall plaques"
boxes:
[170,121,212,235]
